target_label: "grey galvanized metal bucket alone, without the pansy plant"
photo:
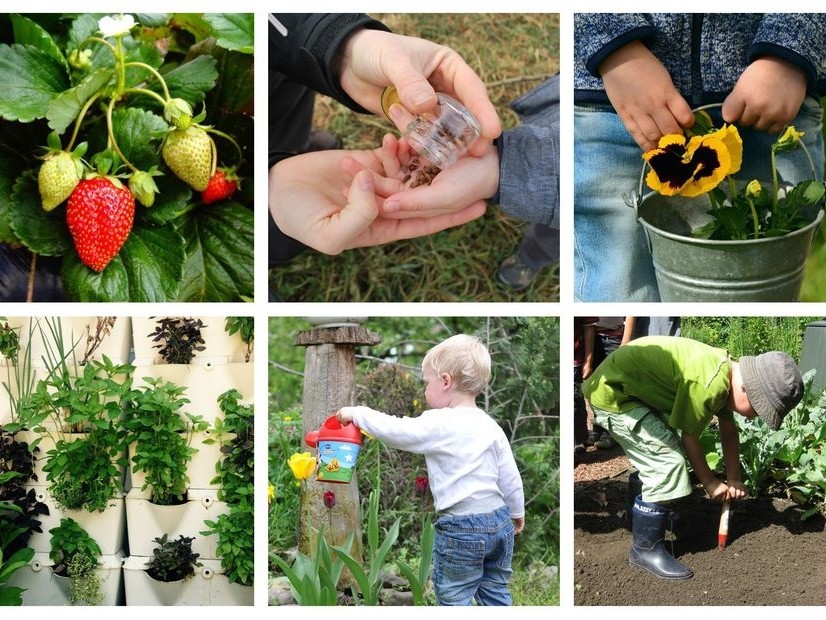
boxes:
[628,106,823,302]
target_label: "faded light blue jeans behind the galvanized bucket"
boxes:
[574,97,823,301]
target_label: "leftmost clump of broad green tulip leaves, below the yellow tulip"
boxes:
[271,532,352,606]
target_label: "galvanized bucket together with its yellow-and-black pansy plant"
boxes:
[632,110,826,301]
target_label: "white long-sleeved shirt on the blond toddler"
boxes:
[348,407,525,518]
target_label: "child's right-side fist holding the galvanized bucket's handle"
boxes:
[723,56,806,133]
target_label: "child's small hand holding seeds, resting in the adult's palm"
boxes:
[342,136,499,219]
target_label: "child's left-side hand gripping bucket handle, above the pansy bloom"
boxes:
[599,41,694,151]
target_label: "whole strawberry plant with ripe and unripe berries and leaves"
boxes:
[0,13,253,301]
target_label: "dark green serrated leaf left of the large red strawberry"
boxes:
[9,170,72,256]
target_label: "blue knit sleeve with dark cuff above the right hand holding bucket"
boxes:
[748,13,826,89]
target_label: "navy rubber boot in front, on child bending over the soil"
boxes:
[628,497,694,579]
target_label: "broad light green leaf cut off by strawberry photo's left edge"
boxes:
[0,45,70,123]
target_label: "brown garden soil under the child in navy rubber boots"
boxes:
[574,448,826,606]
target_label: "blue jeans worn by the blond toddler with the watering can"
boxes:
[433,506,513,605]
